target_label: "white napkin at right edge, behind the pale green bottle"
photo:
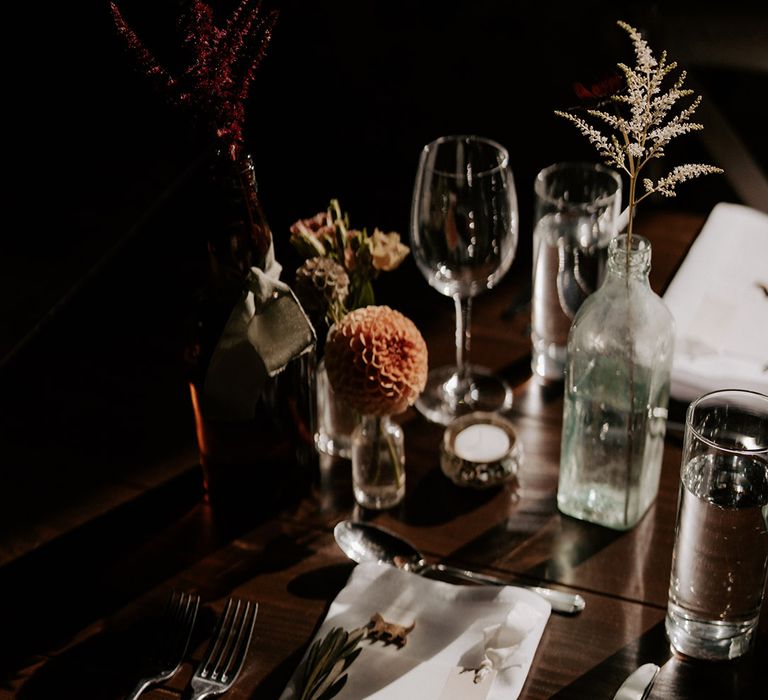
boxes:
[664,203,768,401]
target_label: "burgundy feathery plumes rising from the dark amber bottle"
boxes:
[111,0,277,161]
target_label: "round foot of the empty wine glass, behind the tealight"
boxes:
[416,365,512,425]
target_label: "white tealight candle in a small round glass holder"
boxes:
[440,411,523,488]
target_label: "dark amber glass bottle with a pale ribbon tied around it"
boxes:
[187,155,314,506]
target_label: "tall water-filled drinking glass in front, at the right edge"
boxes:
[666,390,768,660]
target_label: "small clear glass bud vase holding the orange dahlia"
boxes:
[352,416,405,510]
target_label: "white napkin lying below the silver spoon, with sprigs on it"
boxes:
[280,564,551,700]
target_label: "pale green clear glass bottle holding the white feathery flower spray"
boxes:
[557,235,674,530]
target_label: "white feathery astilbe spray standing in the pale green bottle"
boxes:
[555,22,723,247]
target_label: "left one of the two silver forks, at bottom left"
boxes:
[126,591,200,700]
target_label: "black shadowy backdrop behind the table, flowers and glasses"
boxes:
[0,0,768,556]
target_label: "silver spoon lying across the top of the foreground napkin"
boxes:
[333,520,586,615]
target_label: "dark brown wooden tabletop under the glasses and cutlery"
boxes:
[0,213,768,700]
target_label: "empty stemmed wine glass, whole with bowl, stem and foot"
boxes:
[411,136,518,425]
